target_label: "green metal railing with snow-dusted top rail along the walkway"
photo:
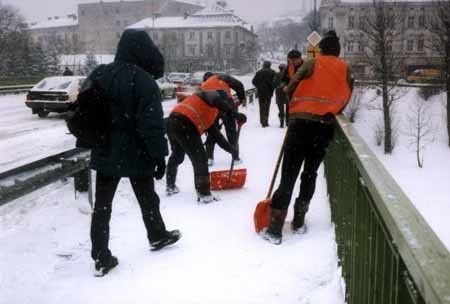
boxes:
[325,117,450,304]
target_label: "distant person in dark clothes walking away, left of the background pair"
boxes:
[252,61,275,128]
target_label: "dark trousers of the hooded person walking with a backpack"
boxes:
[91,172,166,262]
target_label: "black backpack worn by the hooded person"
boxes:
[66,78,111,148]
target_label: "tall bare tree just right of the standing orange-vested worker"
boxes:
[358,0,404,154]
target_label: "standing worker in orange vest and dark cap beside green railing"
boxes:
[263,31,353,244]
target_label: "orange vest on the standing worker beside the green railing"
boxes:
[289,56,351,115]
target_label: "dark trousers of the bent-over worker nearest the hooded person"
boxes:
[166,116,211,195]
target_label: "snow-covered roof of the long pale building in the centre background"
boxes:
[128,5,251,30]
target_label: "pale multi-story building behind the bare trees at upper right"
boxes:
[320,0,443,77]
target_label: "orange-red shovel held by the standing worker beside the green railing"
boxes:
[253,131,286,233]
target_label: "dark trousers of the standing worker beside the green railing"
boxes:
[272,120,334,209]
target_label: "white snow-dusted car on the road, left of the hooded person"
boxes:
[25,76,86,117]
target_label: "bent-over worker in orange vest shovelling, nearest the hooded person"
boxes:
[166,90,247,204]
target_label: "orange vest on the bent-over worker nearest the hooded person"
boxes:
[172,94,219,135]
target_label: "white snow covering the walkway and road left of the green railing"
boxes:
[0,93,344,304]
